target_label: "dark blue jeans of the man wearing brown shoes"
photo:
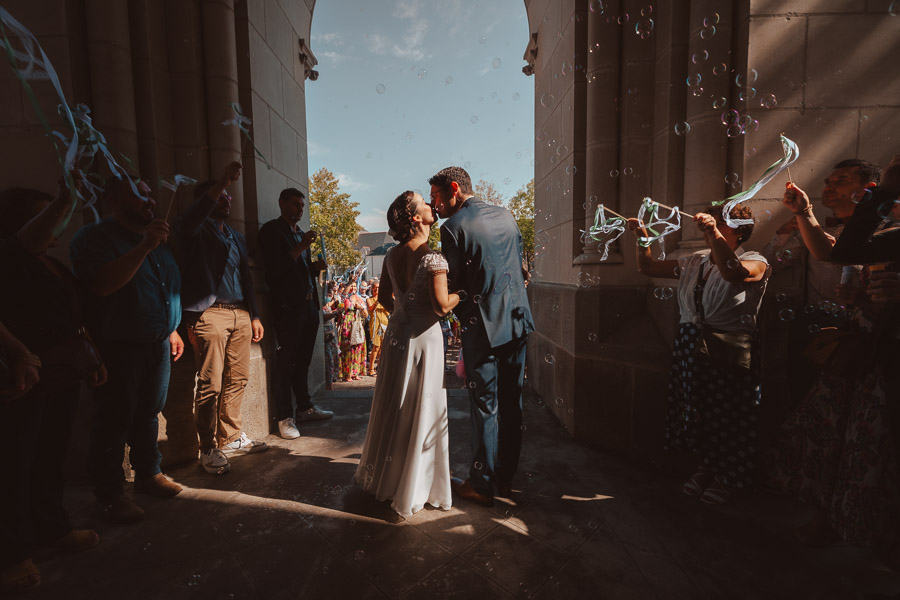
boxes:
[88,338,172,501]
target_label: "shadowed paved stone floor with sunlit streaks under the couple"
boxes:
[19,390,900,600]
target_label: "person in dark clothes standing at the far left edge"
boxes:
[0,185,106,593]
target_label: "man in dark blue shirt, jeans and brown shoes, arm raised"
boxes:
[70,179,184,523]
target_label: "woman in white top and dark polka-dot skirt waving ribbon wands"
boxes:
[628,205,769,504]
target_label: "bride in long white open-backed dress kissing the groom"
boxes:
[354,191,460,517]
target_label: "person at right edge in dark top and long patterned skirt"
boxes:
[773,157,900,556]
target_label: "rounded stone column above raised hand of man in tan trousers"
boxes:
[200,0,245,232]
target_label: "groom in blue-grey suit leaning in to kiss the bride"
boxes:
[428,167,534,506]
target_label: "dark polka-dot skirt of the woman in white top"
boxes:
[666,323,760,490]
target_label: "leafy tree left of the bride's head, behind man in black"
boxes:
[309,167,363,272]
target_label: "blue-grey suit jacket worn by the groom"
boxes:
[441,197,534,352]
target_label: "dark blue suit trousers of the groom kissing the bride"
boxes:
[463,338,525,496]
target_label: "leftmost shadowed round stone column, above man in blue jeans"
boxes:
[85,0,140,175]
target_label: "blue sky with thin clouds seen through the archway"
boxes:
[306,0,534,231]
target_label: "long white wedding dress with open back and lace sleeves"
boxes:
[354,253,451,517]
